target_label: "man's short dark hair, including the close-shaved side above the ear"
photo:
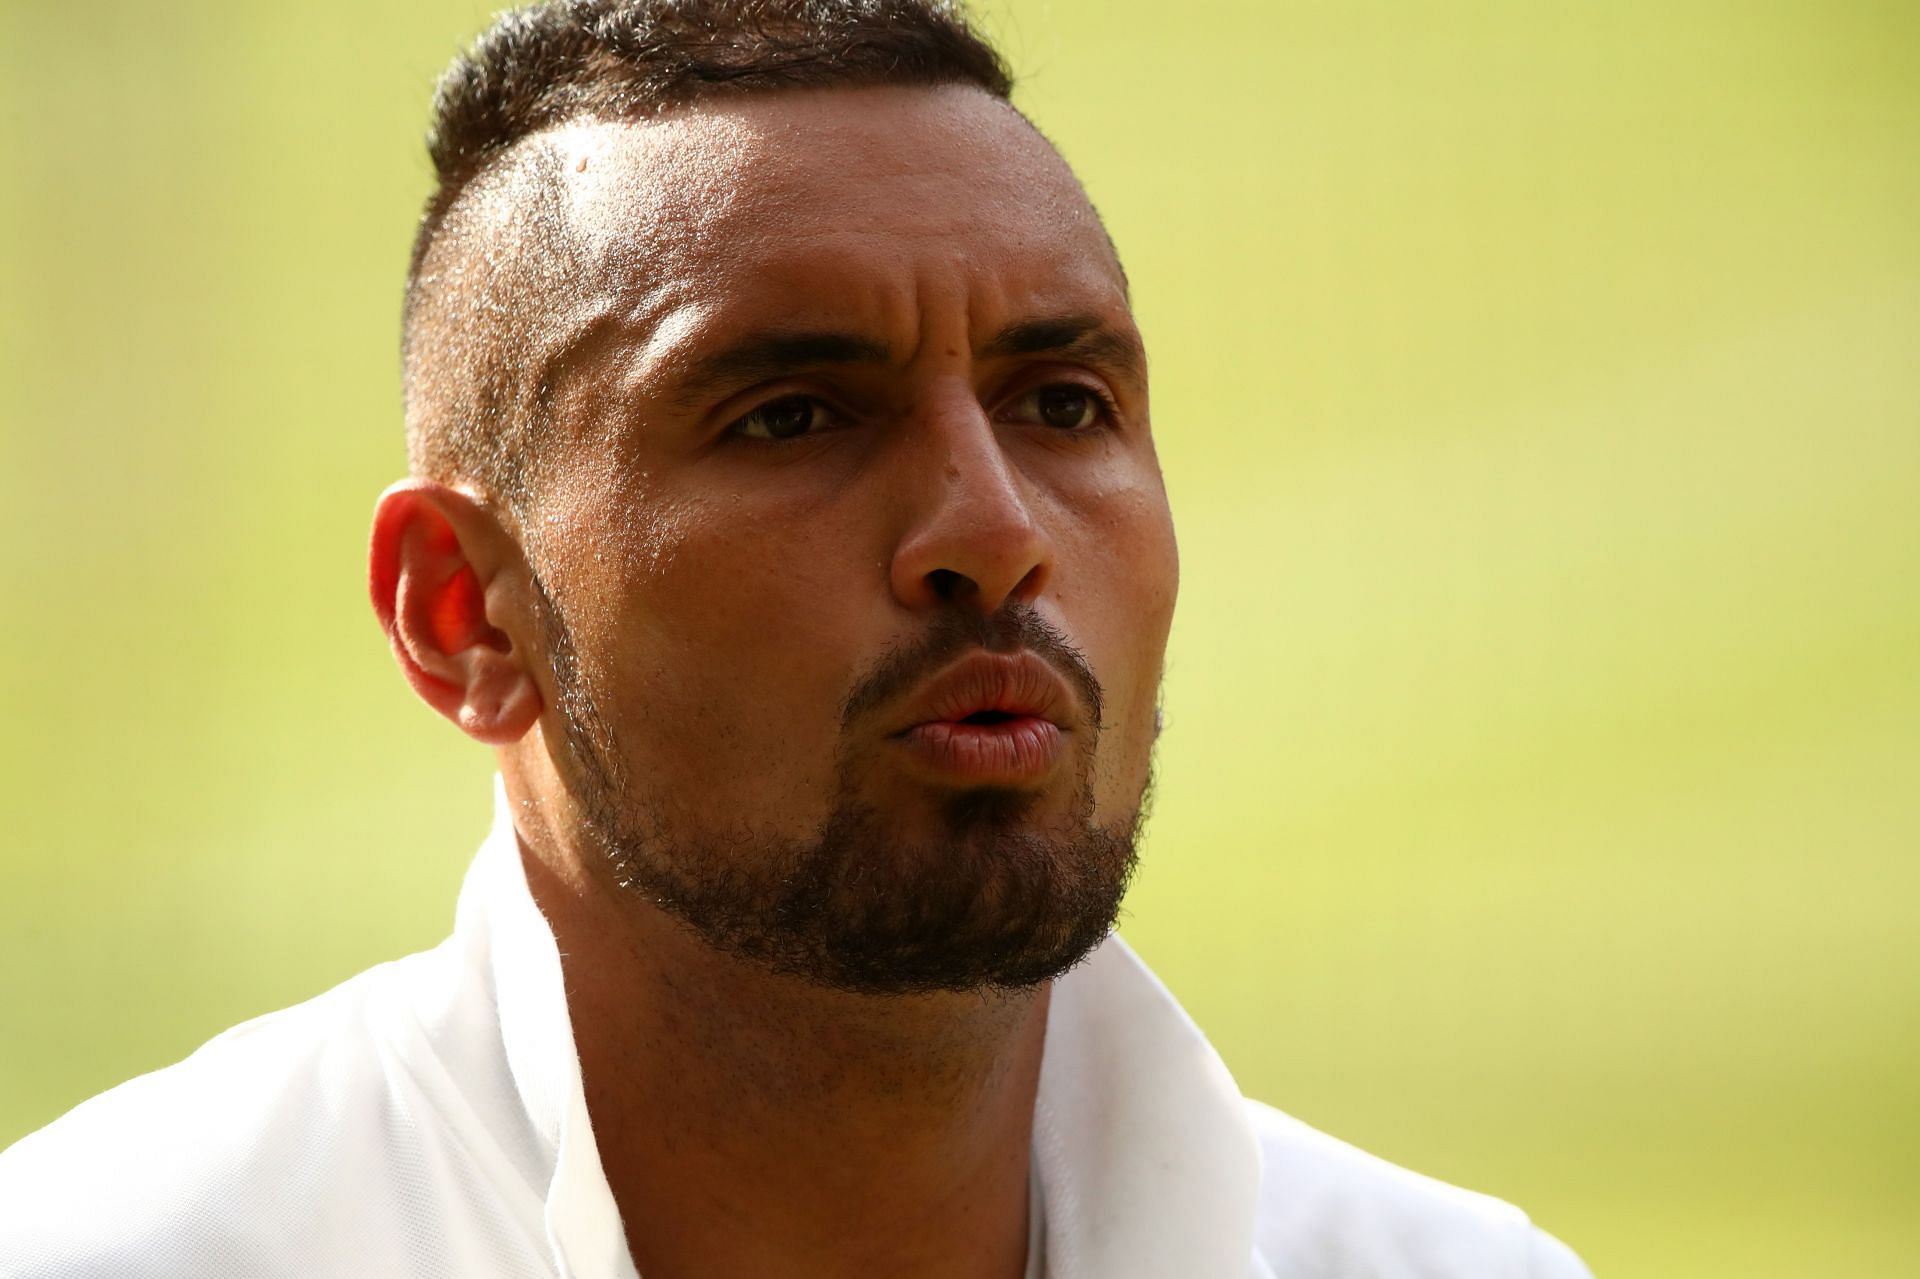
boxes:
[401,0,1012,507]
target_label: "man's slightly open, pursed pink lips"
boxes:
[891,653,1075,787]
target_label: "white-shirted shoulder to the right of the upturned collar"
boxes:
[1246,1100,1590,1279]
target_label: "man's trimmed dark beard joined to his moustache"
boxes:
[536,576,1144,995]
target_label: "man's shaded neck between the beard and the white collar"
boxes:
[522,825,1046,1279]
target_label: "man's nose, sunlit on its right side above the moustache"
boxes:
[891,390,1054,616]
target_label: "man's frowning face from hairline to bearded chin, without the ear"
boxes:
[503,88,1177,991]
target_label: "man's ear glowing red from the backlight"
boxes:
[367,480,541,745]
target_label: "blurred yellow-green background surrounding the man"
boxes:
[0,0,1920,1277]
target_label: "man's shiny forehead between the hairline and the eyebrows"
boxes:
[547,86,1125,337]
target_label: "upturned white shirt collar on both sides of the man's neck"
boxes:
[455,778,1260,1279]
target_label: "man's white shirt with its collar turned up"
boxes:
[0,787,1588,1279]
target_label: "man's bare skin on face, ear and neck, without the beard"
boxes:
[372,88,1177,1279]
